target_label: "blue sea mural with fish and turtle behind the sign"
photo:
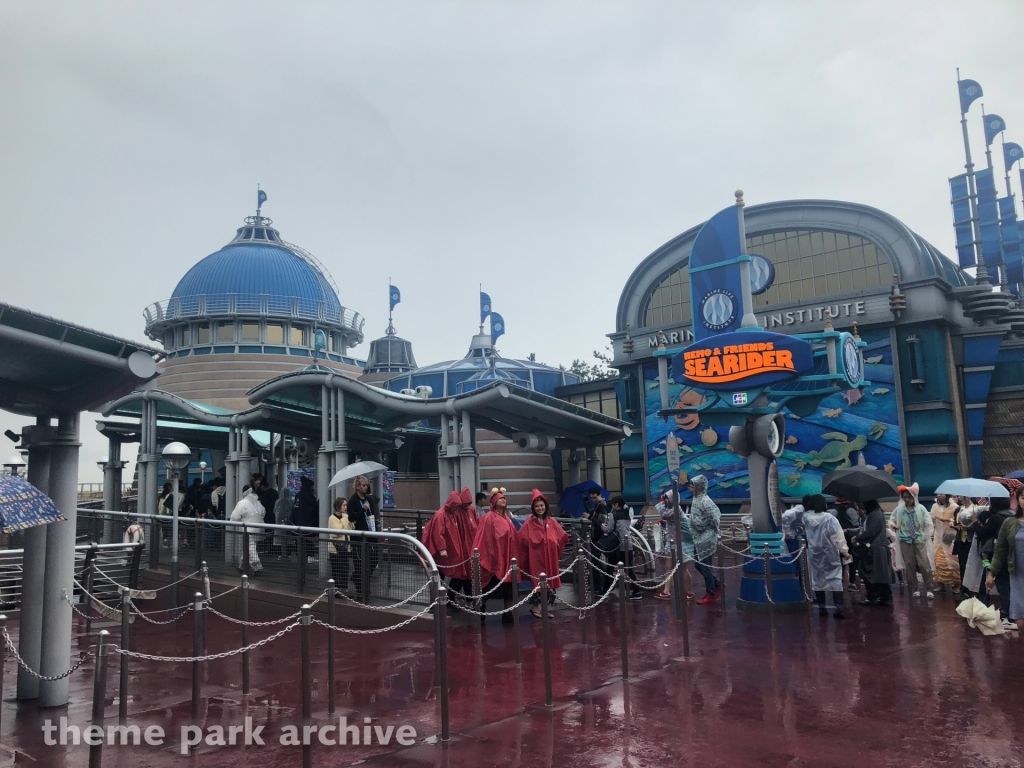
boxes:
[643,330,903,501]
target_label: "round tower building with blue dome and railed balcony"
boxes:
[143,211,365,411]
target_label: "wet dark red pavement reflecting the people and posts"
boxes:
[0,574,1024,768]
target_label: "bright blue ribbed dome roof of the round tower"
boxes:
[171,244,341,316]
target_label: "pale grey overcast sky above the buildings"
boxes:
[0,0,1024,481]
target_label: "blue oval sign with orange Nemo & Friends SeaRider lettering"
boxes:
[672,331,814,390]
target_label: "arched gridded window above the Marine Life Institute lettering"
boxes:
[644,229,893,328]
